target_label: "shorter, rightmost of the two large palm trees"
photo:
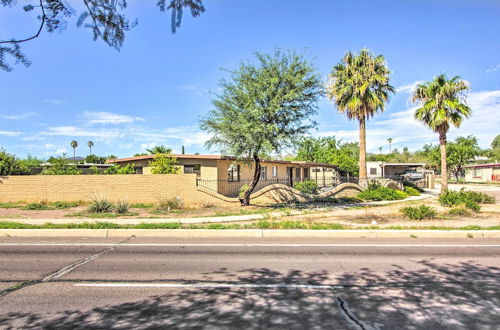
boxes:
[412,74,472,193]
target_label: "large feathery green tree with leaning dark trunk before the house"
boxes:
[201,50,322,205]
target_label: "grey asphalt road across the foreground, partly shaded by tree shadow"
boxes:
[0,238,500,330]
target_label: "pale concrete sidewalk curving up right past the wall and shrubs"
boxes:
[1,194,433,225]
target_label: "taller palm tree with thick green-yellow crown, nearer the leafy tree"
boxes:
[327,48,395,184]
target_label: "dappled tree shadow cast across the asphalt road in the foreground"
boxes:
[0,261,500,329]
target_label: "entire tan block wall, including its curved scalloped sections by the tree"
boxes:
[0,174,368,206]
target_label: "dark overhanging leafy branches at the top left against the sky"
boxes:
[0,0,205,71]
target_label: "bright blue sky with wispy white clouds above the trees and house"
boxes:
[0,0,500,158]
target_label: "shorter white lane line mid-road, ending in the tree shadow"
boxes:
[73,282,343,290]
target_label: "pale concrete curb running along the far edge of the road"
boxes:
[0,229,500,238]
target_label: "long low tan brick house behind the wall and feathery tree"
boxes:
[108,155,338,196]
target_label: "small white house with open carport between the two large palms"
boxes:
[366,161,429,179]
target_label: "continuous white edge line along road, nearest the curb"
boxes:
[0,243,500,248]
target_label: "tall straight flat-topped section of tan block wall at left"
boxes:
[0,174,221,205]
